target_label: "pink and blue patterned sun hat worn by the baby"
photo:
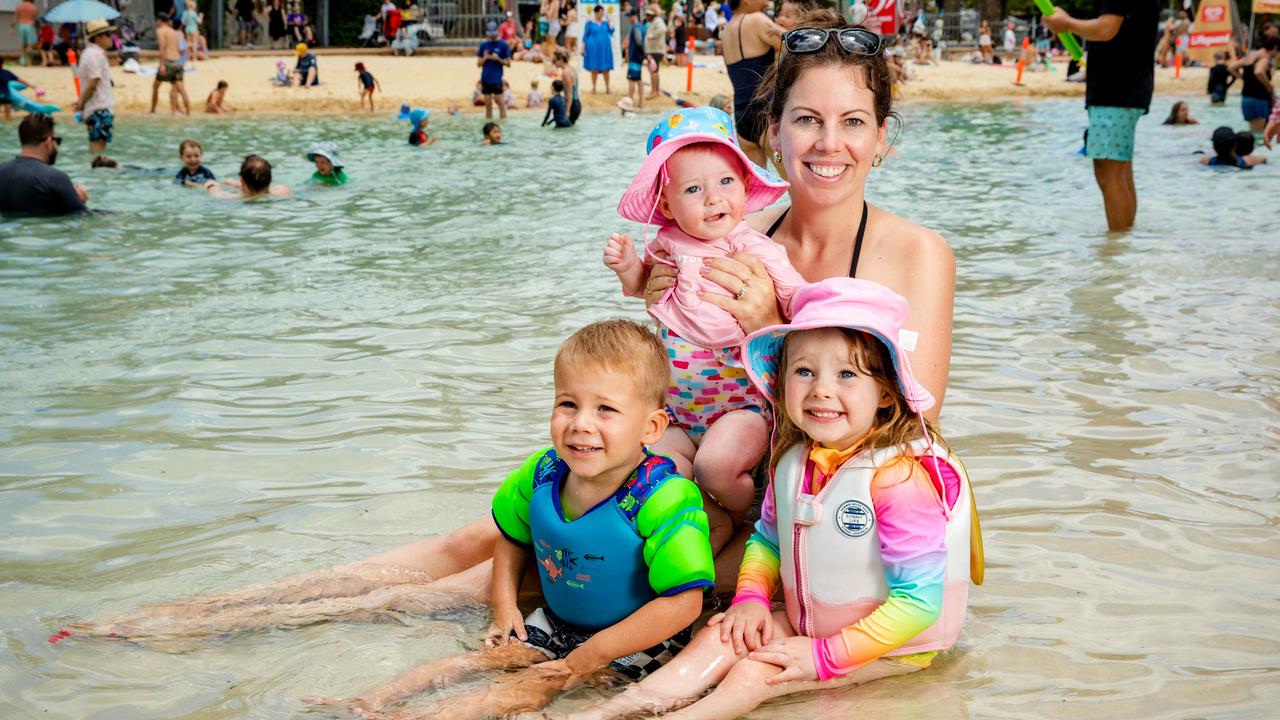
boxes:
[618,105,791,224]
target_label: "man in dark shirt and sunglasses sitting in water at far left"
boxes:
[0,113,88,215]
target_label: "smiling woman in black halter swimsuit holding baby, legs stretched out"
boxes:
[70,3,955,645]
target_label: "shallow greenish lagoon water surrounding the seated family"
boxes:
[0,99,1280,720]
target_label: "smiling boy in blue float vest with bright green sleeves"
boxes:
[305,320,714,717]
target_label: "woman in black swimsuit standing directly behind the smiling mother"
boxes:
[721,0,782,165]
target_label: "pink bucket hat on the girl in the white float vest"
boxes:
[742,278,933,413]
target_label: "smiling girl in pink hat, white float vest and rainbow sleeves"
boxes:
[578,278,982,717]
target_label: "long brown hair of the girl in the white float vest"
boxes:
[769,328,941,471]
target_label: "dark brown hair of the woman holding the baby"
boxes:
[753,9,896,126]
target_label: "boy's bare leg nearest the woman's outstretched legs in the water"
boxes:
[306,642,547,711]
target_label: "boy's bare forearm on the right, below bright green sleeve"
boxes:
[564,588,703,675]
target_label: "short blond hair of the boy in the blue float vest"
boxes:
[556,318,671,407]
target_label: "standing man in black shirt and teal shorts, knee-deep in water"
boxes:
[1044,0,1161,232]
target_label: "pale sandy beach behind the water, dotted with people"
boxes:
[12,51,1208,115]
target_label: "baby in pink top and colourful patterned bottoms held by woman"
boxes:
[604,106,804,550]
